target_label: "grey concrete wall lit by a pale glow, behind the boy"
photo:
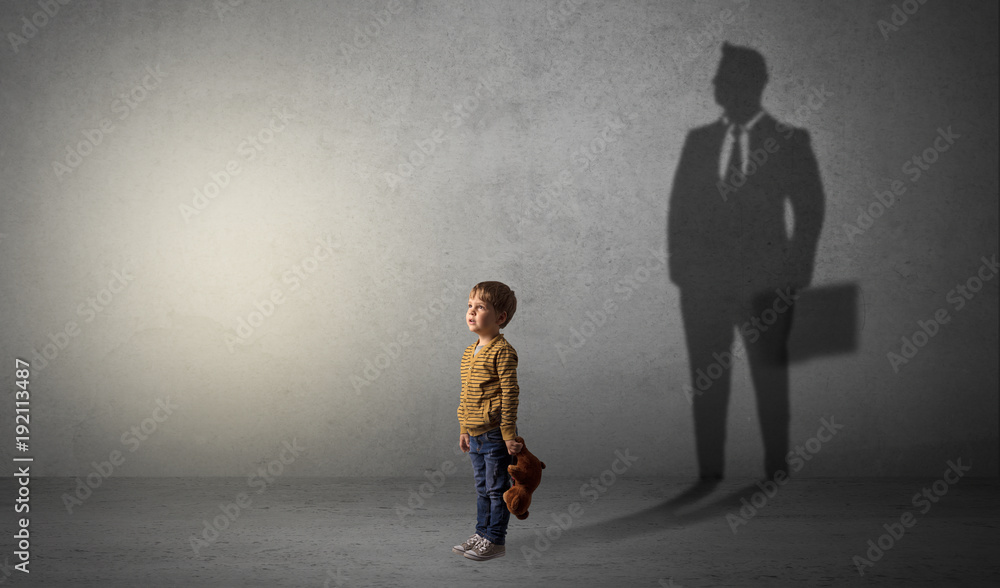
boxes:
[0,0,998,476]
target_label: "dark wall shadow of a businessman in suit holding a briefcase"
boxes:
[667,44,857,481]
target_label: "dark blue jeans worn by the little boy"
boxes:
[469,427,513,545]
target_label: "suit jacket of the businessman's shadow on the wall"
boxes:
[667,114,825,294]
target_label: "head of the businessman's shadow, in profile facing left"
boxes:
[712,43,767,122]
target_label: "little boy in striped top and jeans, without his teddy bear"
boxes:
[452,282,521,561]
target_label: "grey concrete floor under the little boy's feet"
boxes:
[0,474,1000,588]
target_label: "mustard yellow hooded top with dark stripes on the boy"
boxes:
[458,335,519,440]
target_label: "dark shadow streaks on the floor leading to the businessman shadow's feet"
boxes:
[547,480,760,549]
